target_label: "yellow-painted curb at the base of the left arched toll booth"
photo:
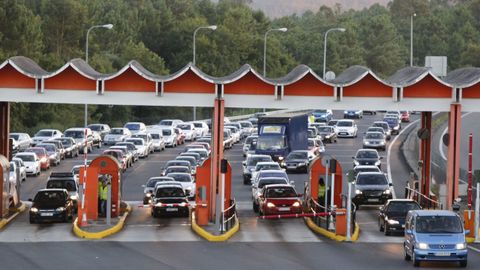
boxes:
[73,202,132,239]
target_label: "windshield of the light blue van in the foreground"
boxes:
[416,215,463,233]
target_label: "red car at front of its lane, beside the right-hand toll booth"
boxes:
[258,184,302,216]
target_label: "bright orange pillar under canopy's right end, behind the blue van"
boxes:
[446,104,462,210]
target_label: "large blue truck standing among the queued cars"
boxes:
[255,114,308,161]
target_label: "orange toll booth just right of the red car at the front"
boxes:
[310,157,343,207]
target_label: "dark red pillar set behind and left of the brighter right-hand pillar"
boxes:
[420,112,432,197]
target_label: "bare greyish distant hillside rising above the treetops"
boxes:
[248,0,390,18]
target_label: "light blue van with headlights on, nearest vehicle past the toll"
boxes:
[403,210,470,267]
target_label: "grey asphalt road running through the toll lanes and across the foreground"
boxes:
[0,112,480,269]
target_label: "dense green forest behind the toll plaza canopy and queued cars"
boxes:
[0,0,480,132]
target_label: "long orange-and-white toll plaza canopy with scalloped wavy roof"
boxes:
[0,56,480,111]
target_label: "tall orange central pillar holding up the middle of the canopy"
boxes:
[208,98,225,222]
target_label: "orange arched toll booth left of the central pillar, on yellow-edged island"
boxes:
[78,155,122,222]
